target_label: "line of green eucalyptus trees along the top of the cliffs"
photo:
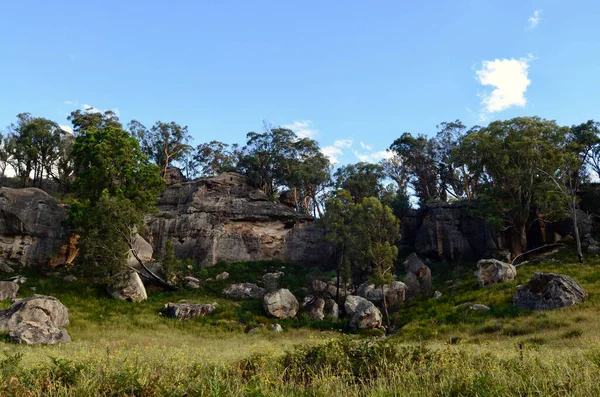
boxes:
[0,110,600,272]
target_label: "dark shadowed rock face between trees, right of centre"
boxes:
[413,203,501,261]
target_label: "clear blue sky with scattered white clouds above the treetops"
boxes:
[0,0,600,163]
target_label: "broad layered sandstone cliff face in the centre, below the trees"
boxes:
[146,173,330,266]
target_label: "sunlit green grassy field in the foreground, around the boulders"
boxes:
[0,251,600,396]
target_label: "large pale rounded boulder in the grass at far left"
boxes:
[0,295,71,344]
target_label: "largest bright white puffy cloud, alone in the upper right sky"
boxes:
[476,55,533,119]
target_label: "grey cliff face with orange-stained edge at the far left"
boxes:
[0,187,77,266]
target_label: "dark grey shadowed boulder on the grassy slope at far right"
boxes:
[513,273,588,310]
